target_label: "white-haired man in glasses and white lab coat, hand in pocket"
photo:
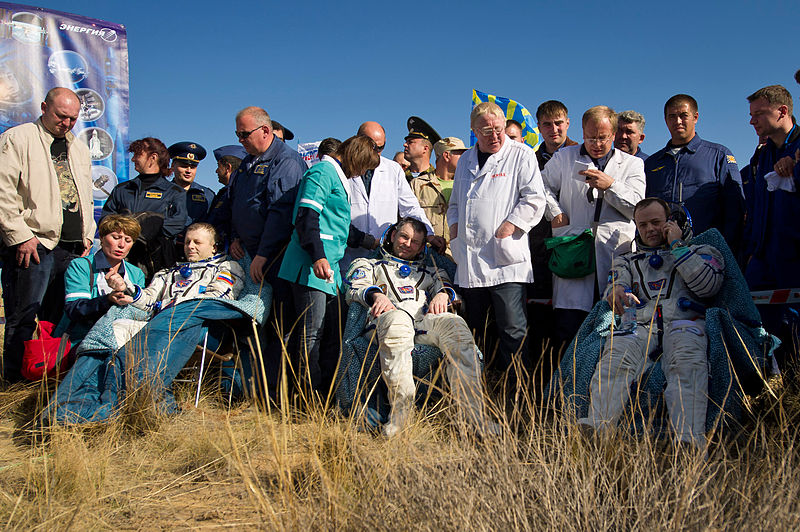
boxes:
[447,102,545,376]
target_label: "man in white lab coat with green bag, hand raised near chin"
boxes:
[542,105,645,342]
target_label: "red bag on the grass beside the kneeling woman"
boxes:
[22,321,72,381]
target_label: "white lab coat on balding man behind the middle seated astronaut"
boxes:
[339,157,433,272]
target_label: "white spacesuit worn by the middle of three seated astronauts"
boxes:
[346,248,498,436]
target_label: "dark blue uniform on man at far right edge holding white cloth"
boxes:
[745,125,800,290]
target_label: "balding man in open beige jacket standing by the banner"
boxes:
[0,87,95,382]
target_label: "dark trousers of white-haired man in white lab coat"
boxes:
[461,283,530,370]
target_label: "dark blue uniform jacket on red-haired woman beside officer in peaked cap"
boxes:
[103,176,186,238]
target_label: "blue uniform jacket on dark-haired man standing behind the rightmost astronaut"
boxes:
[644,135,744,249]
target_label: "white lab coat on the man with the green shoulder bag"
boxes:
[542,145,645,311]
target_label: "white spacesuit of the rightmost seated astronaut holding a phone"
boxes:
[580,236,725,447]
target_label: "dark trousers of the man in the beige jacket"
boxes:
[2,244,78,382]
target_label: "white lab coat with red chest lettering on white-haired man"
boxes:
[447,137,546,288]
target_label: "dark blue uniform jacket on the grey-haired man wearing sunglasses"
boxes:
[228,138,308,266]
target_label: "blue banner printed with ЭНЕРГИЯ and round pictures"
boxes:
[0,2,129,217]
